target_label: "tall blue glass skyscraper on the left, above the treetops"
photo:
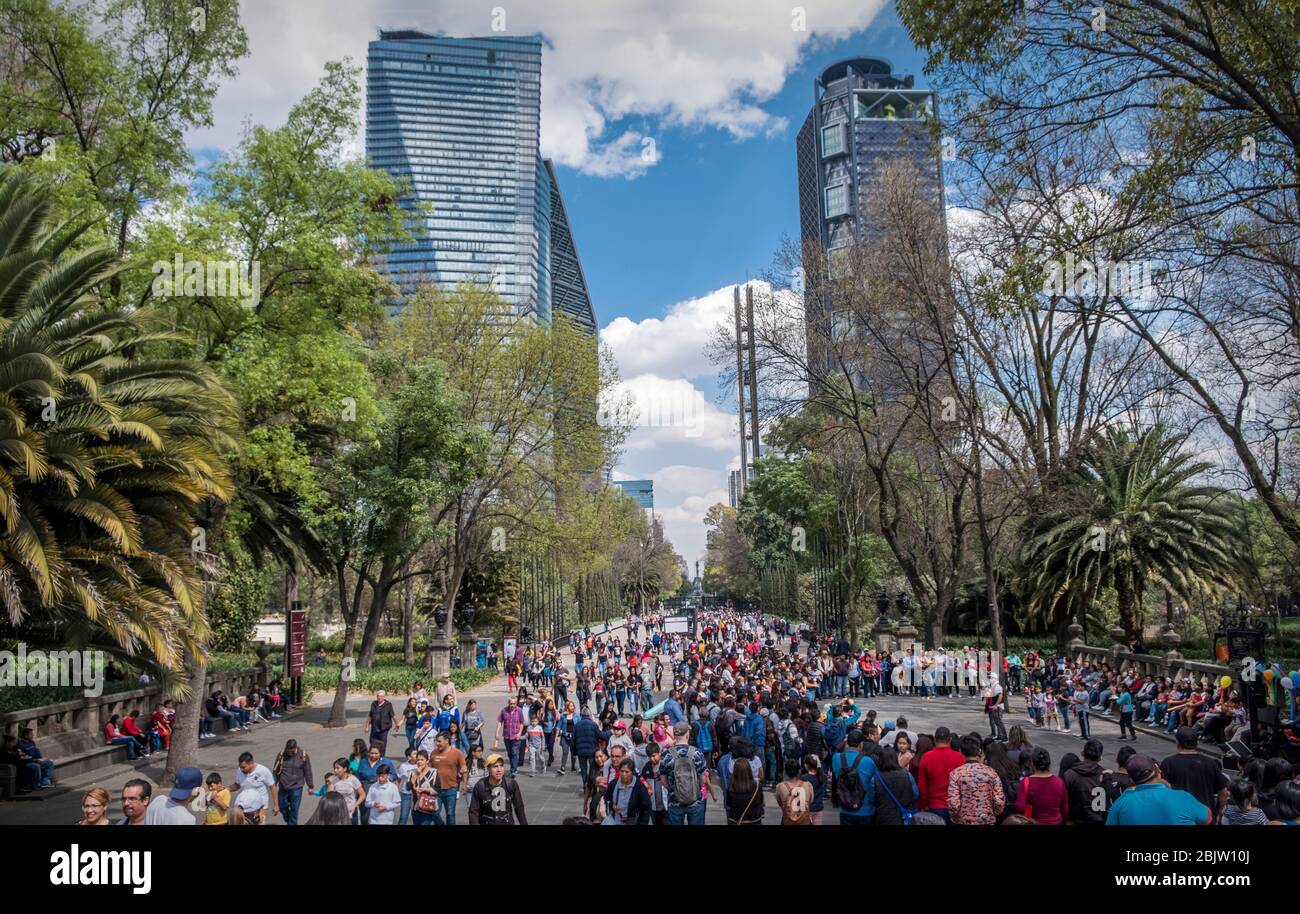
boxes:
[365,29,595,333]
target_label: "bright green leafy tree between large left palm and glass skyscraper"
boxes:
[122,64,406,776]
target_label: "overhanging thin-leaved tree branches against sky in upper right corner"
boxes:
[898,0,1300,545]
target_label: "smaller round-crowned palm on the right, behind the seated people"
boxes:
[1021,426,1245,637]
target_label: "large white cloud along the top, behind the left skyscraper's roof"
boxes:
[190,0,884,177]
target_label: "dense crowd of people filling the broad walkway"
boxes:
[38,608,1300,826]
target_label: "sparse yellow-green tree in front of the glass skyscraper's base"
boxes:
[382,283,620,673]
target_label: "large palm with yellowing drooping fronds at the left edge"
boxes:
[0,169,235,676]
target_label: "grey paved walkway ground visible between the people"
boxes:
[0,626,1196,826]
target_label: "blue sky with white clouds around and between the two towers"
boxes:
[195,0,926,573]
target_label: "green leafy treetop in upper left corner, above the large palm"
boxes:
[0,0,248,261]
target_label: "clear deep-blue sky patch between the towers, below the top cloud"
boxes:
[566,20,924,318]
